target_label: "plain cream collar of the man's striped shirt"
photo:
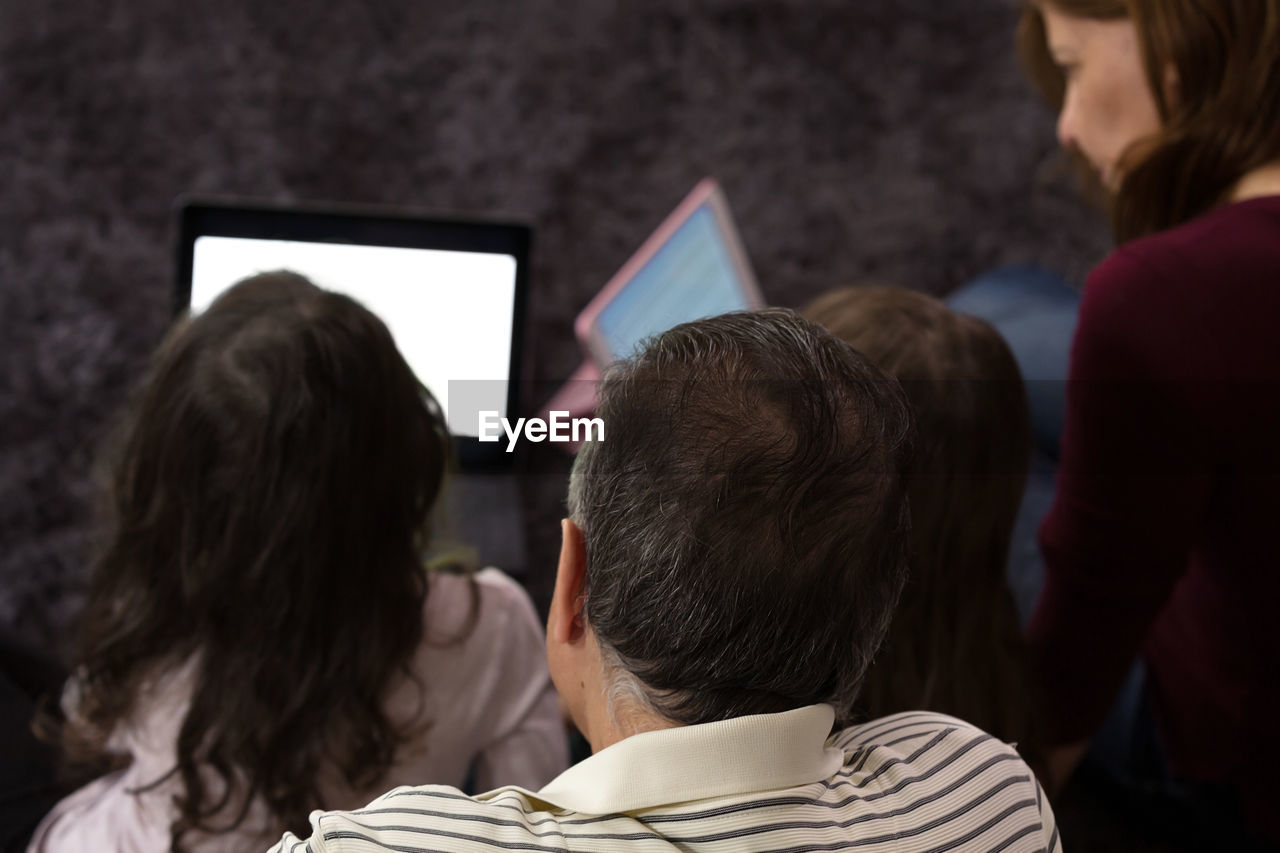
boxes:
[504,704,844,815]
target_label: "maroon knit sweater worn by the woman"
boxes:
[1028,196,1280,839]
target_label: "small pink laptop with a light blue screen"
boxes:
[543,178,764,422]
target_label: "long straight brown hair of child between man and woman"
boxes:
[804,287,1034,757]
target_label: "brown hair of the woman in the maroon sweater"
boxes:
[1018,0,1280,242]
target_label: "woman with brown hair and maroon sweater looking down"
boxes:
[998,0,1280,840]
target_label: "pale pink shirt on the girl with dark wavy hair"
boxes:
[28,569,568,853]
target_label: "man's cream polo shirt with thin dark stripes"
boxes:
[274,704,1061,853]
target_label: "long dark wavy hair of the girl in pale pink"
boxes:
[63,272,458,850]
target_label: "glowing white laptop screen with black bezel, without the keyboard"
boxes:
[178,204,529,467]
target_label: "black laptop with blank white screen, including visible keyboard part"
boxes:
[175,199,530,576]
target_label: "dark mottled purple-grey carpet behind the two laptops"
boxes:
[0,0,1107,644]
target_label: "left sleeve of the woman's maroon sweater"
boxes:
[1028,250,1210,743]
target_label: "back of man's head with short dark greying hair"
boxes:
[570,310,914,724]
